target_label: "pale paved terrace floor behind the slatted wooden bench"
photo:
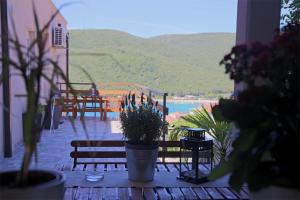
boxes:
[0,117,122,171]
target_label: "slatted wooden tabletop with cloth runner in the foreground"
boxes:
[61,163,249,200]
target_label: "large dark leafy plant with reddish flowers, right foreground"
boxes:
[211,23,300,199]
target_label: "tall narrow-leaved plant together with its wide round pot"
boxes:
[0,9,78,199]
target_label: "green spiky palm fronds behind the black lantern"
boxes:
[182,106,231,163]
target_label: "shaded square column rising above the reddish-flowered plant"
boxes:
[236,0,281,44]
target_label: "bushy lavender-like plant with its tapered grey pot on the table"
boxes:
[120,94,163,182]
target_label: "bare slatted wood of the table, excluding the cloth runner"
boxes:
[58,163,249,200]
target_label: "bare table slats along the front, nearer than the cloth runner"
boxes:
[64,187,249,200]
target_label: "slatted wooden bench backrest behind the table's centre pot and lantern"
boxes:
[70,140,213,169]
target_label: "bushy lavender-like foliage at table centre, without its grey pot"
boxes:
[120,94,163,144]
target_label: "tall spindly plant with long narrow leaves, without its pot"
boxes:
[0,7,81,187]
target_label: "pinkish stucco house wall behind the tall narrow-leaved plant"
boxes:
[0,0,67,156]
